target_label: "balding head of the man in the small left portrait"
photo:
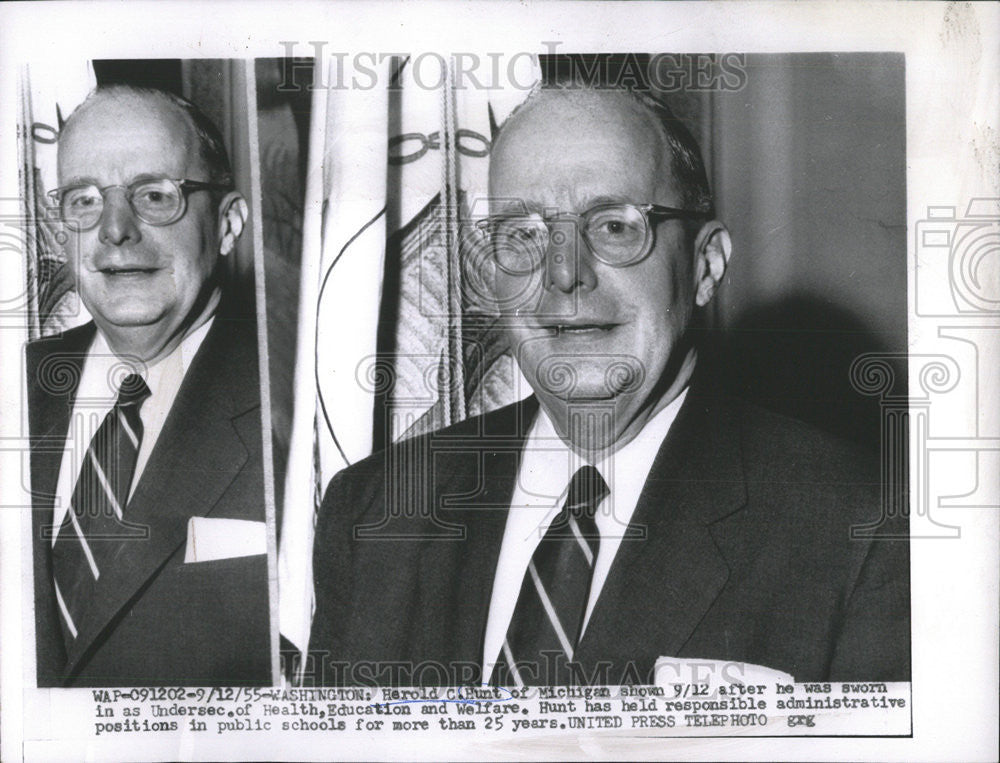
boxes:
[58,87,247,362]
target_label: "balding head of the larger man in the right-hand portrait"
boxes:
[490,88,730,454]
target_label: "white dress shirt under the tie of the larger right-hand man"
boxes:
[483,389,687,677]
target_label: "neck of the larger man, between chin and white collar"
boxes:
[538,347,698,463]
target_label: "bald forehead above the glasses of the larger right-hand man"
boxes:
[490,90,677,211]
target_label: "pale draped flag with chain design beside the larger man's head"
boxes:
[278,55,538,664]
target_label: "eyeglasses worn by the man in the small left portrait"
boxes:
[46,177,229,231]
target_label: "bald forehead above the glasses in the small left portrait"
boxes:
[58,94,202,184]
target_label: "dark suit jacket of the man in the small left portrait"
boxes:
[27,313,271,686]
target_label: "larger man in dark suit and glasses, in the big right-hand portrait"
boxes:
[310,82,909,686]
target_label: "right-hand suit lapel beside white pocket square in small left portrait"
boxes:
[66,318,259,676]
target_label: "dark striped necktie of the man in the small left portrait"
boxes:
[52,374,150,648]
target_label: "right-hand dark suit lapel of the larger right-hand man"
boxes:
[577,393,746,683]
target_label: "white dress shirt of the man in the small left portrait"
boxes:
[52,318,215,545]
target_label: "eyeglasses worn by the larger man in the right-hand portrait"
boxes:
[476,203,711,275]
